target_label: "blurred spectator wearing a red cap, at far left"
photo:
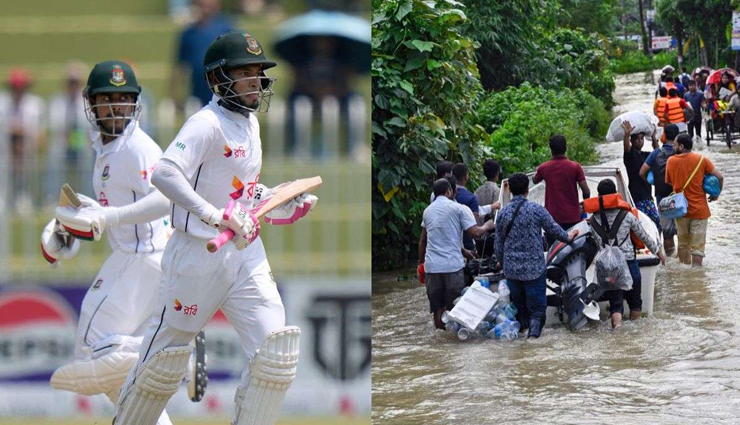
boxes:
[0,68,45,212]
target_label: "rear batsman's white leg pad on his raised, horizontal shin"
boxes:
[51,352,139,395]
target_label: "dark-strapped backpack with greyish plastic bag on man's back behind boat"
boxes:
[589,210,632,291]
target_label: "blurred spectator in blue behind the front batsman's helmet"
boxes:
[170,0,232,106]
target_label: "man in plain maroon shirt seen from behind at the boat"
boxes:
[532,134,591,246]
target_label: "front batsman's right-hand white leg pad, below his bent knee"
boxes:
[233,326,301,425]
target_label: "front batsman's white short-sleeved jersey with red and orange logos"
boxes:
[162,96,262,239]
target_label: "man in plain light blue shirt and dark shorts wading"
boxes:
[419,176,494,329]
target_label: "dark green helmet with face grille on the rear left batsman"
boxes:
[82,61,141,137]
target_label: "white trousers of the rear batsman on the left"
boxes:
[75,251,172,425]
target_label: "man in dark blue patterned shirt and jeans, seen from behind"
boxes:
[495,173,578,338]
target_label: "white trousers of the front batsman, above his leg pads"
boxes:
[131,230,285,387]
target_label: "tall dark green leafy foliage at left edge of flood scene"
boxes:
[372,0,485,267]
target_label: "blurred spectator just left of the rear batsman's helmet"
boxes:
[46,62,93,204]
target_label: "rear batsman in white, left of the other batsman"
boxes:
[42,61,172,425]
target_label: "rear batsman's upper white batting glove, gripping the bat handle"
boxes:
[56,194,118,241]
